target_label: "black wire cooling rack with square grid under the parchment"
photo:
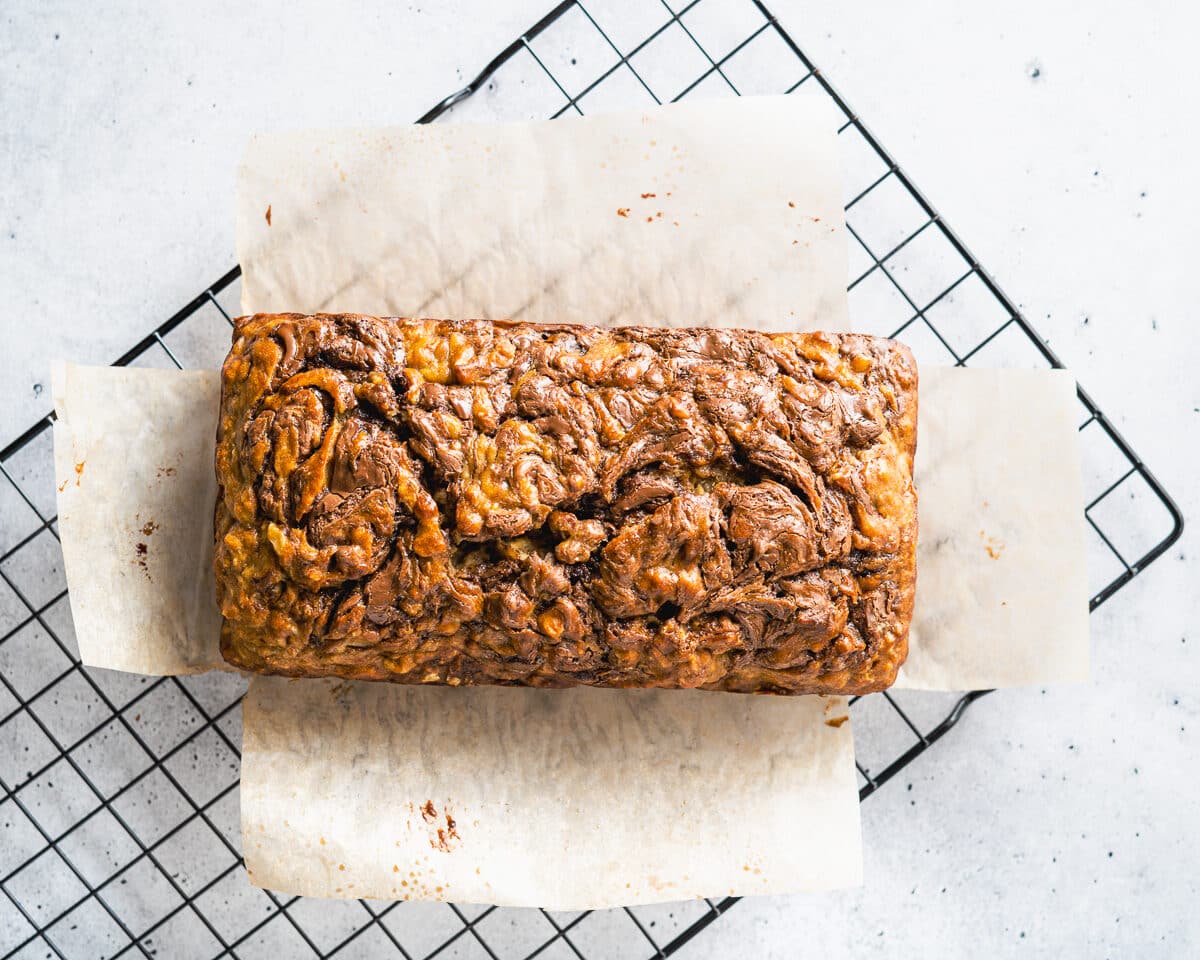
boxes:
[0,0,1183,960]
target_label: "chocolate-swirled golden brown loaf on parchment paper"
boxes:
[216,314,917,694]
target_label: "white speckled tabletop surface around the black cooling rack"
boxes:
[0,0,1200,958]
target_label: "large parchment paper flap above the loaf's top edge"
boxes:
[238,96,847,330]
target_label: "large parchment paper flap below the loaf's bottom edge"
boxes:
[241,677,862,910]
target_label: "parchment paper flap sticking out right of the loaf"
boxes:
[896,367,1088,690]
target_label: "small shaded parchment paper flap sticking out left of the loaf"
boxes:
[53,364,224,676]
